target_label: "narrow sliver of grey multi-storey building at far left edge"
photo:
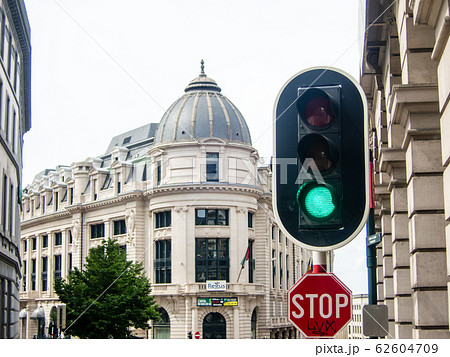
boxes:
[0,0,31,338]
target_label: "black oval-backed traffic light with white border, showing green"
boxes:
[272,68,369,250]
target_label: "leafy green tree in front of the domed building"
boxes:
[55,239,159,338]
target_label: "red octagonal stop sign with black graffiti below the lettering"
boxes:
[287,273,352,338]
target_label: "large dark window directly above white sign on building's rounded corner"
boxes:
[195,238,230,282]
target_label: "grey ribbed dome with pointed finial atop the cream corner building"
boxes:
[154,60,252,145]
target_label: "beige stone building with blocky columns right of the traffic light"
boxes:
[361,0,450,338]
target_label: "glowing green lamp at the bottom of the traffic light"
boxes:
[297,182,337,221]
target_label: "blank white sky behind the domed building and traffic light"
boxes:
[23,0,367,293]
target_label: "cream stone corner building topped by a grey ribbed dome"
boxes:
[20,64,309,338]
